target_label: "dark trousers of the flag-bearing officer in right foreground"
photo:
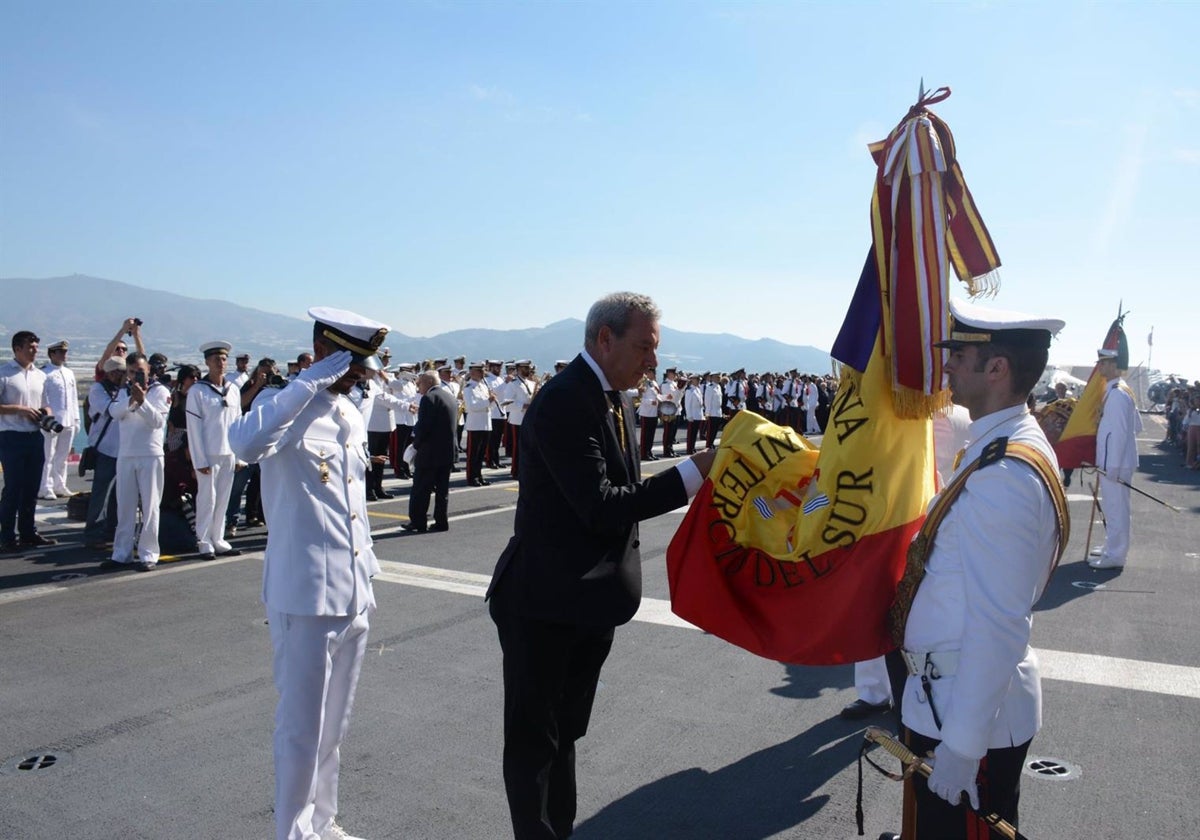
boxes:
[901,728,1032,840]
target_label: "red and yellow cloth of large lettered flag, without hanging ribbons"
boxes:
[667,258,936,665]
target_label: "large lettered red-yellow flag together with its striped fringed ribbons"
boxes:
[667,88,1000,665]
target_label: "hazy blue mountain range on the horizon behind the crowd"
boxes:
[0,275,829,373]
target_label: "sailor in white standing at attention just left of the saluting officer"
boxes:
[187,341,241,560]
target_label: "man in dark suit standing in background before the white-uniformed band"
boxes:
[404,371,458,533]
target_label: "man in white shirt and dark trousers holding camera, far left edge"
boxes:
[0,330,61,553]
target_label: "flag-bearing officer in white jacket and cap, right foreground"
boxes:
[884,301,1069,840]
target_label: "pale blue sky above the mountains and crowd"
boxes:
[0,0,1200,377]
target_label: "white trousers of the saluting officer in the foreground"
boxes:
[266,610,371,840]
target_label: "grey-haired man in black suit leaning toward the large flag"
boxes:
[487,293,714,840]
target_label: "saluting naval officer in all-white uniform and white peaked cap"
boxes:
[229,306,388,840]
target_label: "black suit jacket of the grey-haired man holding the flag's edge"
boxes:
[487,355,688,626]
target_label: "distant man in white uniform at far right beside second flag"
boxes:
[1087,350,1142,569]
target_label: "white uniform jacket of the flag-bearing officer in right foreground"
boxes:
[901,404,1058,758]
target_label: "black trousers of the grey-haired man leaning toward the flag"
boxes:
[490,598,613,840]
